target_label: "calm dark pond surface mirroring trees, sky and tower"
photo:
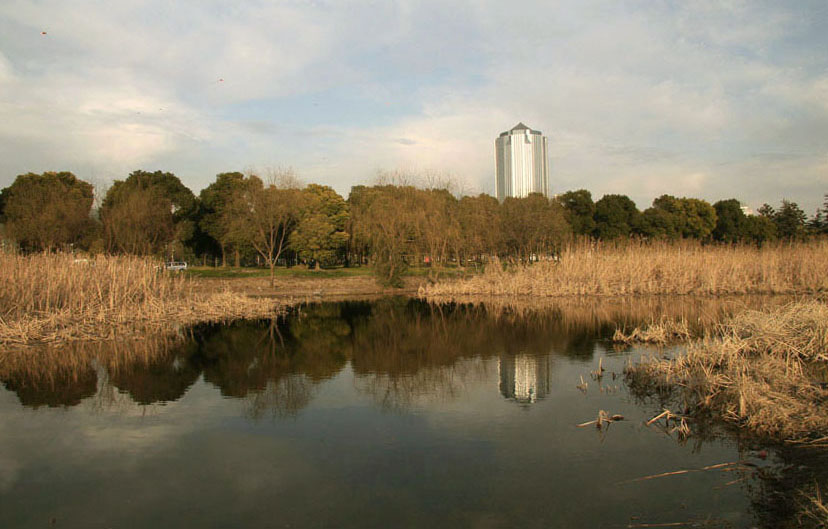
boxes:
[0,298,826,528]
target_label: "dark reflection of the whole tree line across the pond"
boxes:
[0,297,788,415]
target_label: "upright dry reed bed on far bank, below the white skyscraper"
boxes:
[420,240,828,297]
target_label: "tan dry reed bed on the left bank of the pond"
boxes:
[0,254,288,348]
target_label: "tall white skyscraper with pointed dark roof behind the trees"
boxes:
[495,123,549,201]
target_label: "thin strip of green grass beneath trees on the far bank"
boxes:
[185,266,474,278]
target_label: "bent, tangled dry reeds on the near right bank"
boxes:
[626,300,828,443]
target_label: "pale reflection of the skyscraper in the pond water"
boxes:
[497,355,552,404]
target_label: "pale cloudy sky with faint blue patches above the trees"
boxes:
[0,0,828,215]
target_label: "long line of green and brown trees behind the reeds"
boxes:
[0,170,828,284]
